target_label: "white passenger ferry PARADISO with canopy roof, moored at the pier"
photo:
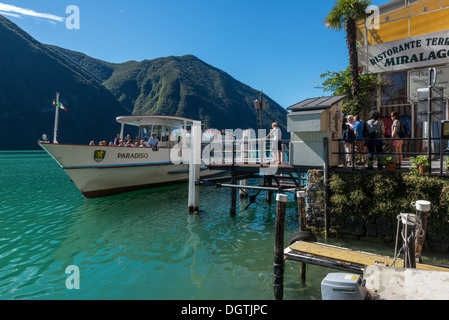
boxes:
[39,116,220,198]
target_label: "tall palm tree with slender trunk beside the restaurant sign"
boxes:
[324,0,371,112]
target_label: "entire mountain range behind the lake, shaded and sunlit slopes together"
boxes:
[0,15,287,150]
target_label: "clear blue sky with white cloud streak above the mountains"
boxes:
[0,0,389,108]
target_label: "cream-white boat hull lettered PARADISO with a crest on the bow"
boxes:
[40,143,221,198]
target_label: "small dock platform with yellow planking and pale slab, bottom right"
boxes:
[284,241,449,300]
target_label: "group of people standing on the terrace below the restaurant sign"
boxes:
[342,110,403,170]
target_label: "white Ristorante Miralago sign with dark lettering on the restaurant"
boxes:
[358,30,449,73]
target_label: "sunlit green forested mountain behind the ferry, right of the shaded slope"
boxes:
[50,47,287,132]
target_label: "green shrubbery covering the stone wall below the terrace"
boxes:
[328,172,449,239]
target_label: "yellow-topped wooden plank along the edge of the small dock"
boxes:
[285,241,449,272]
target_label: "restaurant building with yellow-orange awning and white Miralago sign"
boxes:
[357,0,449,151]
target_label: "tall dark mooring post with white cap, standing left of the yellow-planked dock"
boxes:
[273,193,288,300]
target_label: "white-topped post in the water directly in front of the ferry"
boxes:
[188,123,202,212]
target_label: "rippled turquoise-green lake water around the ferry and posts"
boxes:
[0,152,444,300]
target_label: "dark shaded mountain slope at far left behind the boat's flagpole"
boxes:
[0,16,130,150]
